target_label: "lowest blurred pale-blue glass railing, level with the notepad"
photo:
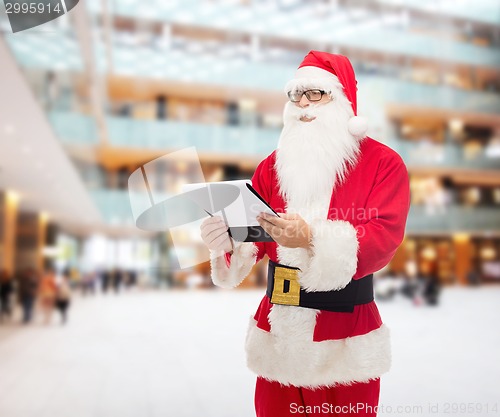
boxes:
[91,189,500,233]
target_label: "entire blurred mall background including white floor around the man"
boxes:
[0,0,500,417]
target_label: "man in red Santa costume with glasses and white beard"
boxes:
[201,51,409,417]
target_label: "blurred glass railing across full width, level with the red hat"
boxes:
[7,37,500,114]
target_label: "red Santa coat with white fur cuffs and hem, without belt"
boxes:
[212,138,409,387]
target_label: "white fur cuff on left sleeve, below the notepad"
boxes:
[210,242,257,288]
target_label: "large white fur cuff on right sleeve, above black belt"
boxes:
[299,219,359,292]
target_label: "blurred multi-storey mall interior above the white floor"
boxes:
[0,0,500,287]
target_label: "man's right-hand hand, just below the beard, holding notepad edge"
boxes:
[257,213,311,249]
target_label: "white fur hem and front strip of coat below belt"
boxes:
[246,305,391,388]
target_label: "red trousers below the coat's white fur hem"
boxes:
[255,377,380,417]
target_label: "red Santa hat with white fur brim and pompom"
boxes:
[285,51,368,138]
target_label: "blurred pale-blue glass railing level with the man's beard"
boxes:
[49,112,500,169]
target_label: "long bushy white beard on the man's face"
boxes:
[276,99,360,211]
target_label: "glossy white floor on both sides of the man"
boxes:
[0,287,500,417]
